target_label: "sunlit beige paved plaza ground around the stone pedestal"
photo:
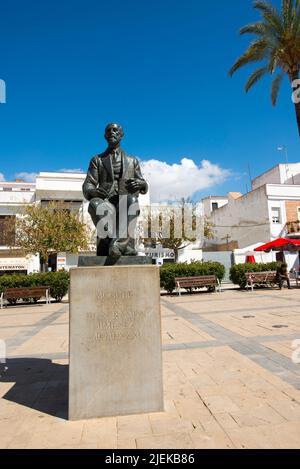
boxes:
[0,289,300,449]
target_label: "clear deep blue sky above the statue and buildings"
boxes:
[0,0,299,199]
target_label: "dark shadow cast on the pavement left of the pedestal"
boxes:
[0,358,69,419]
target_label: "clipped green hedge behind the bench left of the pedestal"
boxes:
[0,272,69,302]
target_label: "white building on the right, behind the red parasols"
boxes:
[210,163,300,268]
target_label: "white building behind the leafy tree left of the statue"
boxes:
[0,172,150,275]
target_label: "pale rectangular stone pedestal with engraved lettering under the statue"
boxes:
[69,265,163,420]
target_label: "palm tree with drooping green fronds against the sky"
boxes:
[229,0,300,136]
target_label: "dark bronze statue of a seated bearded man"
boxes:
[83,124,148,257]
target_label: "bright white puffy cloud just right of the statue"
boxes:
[141,158,231,202]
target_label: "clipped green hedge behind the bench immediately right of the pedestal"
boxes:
[160,261,225,293]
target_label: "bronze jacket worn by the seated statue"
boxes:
[82,150,148,200]
